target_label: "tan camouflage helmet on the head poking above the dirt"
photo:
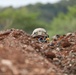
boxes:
[32,28,48,37]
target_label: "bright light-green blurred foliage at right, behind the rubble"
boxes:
[49,6,76,35]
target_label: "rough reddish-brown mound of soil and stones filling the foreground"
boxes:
[0,29,76,75]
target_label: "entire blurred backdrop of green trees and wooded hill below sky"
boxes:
[0,0,76,36]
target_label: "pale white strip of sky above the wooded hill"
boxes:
[0,0,60,7]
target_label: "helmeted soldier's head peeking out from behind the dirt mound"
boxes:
[31,28,50,42]
